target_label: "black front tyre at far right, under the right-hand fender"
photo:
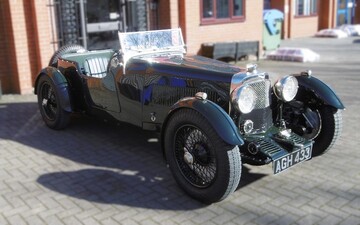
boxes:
[312,107,342,157]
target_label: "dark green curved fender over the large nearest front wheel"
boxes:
[165,97,244,145]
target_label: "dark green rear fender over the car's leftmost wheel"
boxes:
[34,66,72,112]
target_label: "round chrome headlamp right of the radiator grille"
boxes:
[274,76,299,102]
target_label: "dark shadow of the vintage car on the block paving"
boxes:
[0,103,263,210]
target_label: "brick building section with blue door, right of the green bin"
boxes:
[269,0,360,39]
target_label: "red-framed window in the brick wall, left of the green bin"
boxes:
[200,0,245,24]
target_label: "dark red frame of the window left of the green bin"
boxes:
[200,0,246,25]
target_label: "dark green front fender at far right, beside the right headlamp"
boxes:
[295,75,345,109]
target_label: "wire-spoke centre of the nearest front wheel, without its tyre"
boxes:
[175,125,216,188]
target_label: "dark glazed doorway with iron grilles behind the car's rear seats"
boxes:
[53,0,148,50]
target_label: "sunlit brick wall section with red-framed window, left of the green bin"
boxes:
[179,0,263,54]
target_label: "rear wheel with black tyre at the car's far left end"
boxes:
[37,75,70,130]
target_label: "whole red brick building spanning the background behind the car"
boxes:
[0,0,360,94]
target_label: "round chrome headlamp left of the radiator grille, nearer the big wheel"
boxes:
[233,85,256,114]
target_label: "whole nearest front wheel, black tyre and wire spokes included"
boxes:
[164,109,241,204]
